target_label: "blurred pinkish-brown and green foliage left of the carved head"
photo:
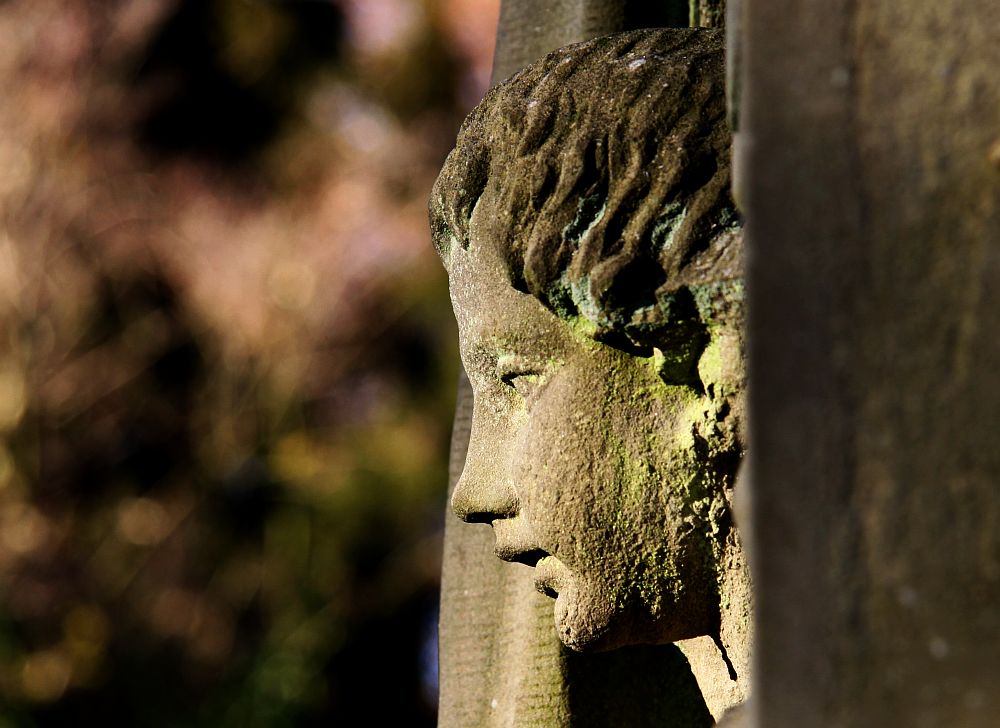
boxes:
[0,0,497,726]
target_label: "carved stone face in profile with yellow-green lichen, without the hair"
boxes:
[451,235,738,649]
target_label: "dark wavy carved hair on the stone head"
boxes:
[430,29,742,370]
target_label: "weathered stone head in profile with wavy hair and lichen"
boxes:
[431,30,744,650]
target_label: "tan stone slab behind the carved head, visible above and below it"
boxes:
[438,0,712,728]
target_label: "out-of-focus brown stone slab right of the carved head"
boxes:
[741,0,1000,728]
